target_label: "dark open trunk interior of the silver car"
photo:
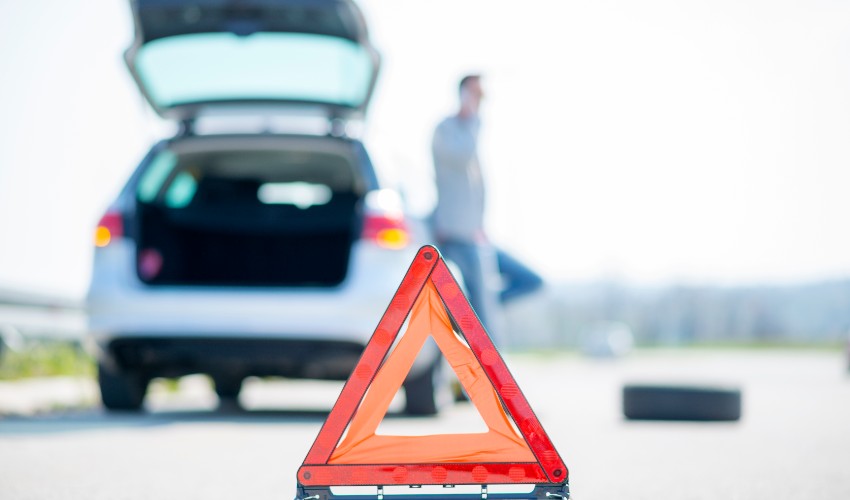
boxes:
[135,139,362,287]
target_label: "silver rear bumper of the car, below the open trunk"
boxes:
[87,244,439,380]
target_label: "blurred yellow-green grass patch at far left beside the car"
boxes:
[0,340,97,380]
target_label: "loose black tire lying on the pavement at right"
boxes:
[623,385,741,421]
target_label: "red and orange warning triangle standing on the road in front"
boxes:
[298,246,569,500]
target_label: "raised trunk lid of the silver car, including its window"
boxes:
[125,0,380,120]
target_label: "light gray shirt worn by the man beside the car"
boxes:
[431,115,484,242]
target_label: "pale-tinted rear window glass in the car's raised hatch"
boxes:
[136,33,373,108]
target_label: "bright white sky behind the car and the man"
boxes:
[0,0,850,296]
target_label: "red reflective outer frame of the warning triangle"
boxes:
[297,245,569,492]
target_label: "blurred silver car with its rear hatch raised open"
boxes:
[87,0,446,414]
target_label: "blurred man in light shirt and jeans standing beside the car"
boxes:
[431,75,499,345]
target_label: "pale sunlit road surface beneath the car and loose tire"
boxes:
[0,351,850,500]
